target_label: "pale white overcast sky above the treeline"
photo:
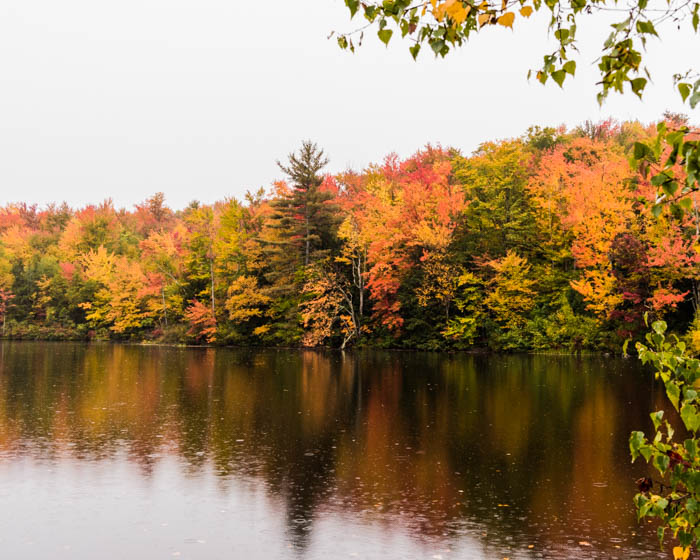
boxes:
[0,0,700,208]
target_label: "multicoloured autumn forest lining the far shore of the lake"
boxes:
[0,114,700,351]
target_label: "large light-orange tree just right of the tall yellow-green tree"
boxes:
[528,137,637,328]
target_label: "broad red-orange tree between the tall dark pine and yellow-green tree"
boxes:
[355,146,465,332]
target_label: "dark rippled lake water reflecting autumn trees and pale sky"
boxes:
[0,343,668,560]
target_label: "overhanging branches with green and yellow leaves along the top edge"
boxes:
[337,0,700,107]
